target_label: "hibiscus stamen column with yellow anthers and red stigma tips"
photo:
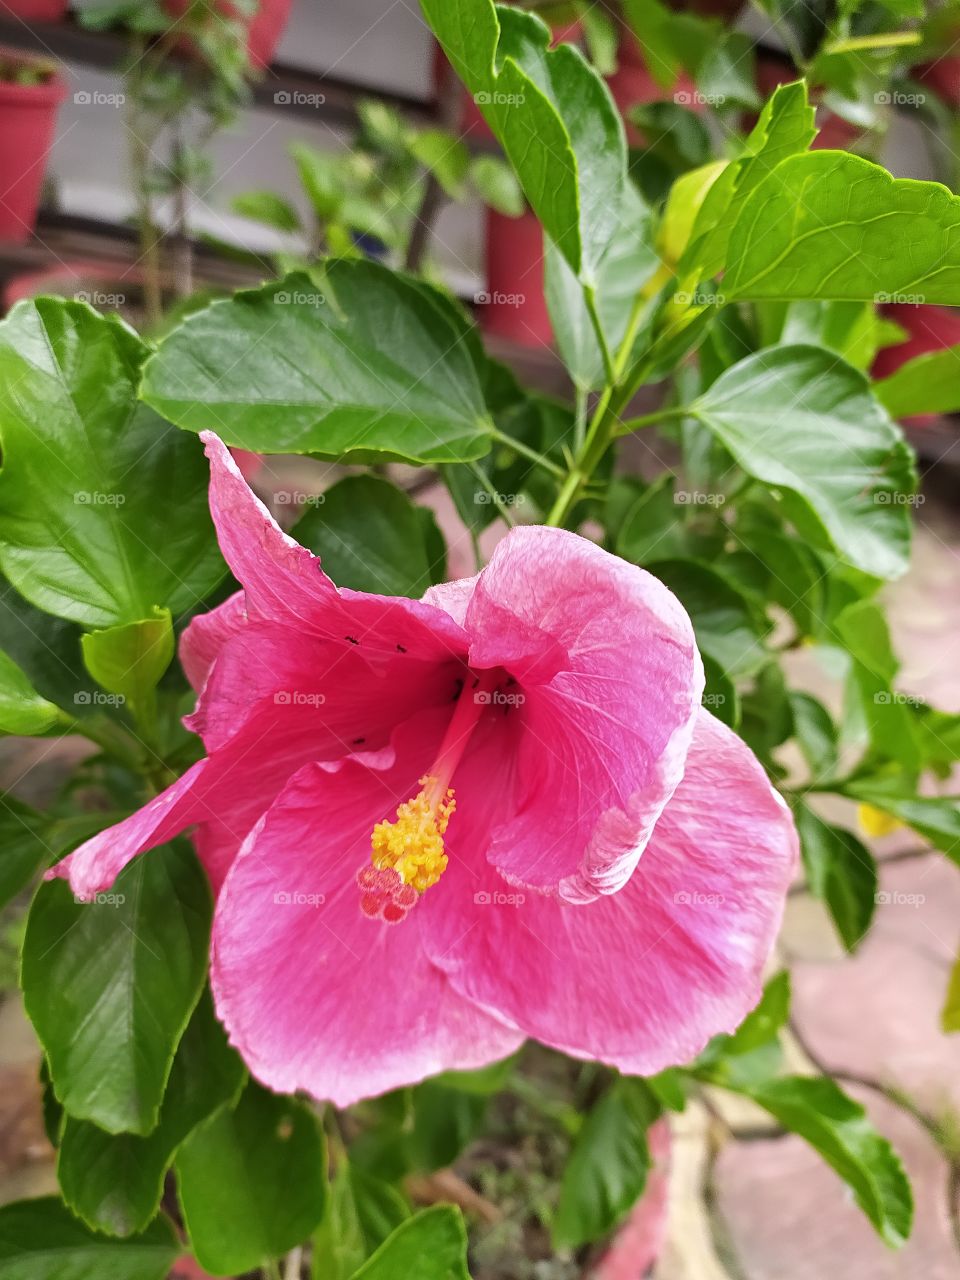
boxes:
[357,671,502,924]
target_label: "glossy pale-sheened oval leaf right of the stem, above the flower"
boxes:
[690,347,916,577]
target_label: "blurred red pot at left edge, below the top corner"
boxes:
[0,49,67,241]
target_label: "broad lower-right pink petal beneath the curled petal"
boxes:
[421,710,797,1075]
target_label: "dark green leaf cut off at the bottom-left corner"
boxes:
[0,1197,182,1280]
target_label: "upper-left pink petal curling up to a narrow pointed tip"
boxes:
[200,431,466,666]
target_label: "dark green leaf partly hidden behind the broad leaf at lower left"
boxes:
[56,992,244,1235]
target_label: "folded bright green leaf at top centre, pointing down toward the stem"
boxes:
[421,0,626,285]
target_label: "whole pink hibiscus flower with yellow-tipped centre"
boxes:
[56,433,796,1105]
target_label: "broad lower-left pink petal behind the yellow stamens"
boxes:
[211,713,521,1106]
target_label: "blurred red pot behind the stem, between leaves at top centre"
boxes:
[476,209,553,347]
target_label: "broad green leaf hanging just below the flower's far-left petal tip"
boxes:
[22,841,211,1134]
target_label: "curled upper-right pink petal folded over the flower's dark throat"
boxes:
[465,527,703,902]
